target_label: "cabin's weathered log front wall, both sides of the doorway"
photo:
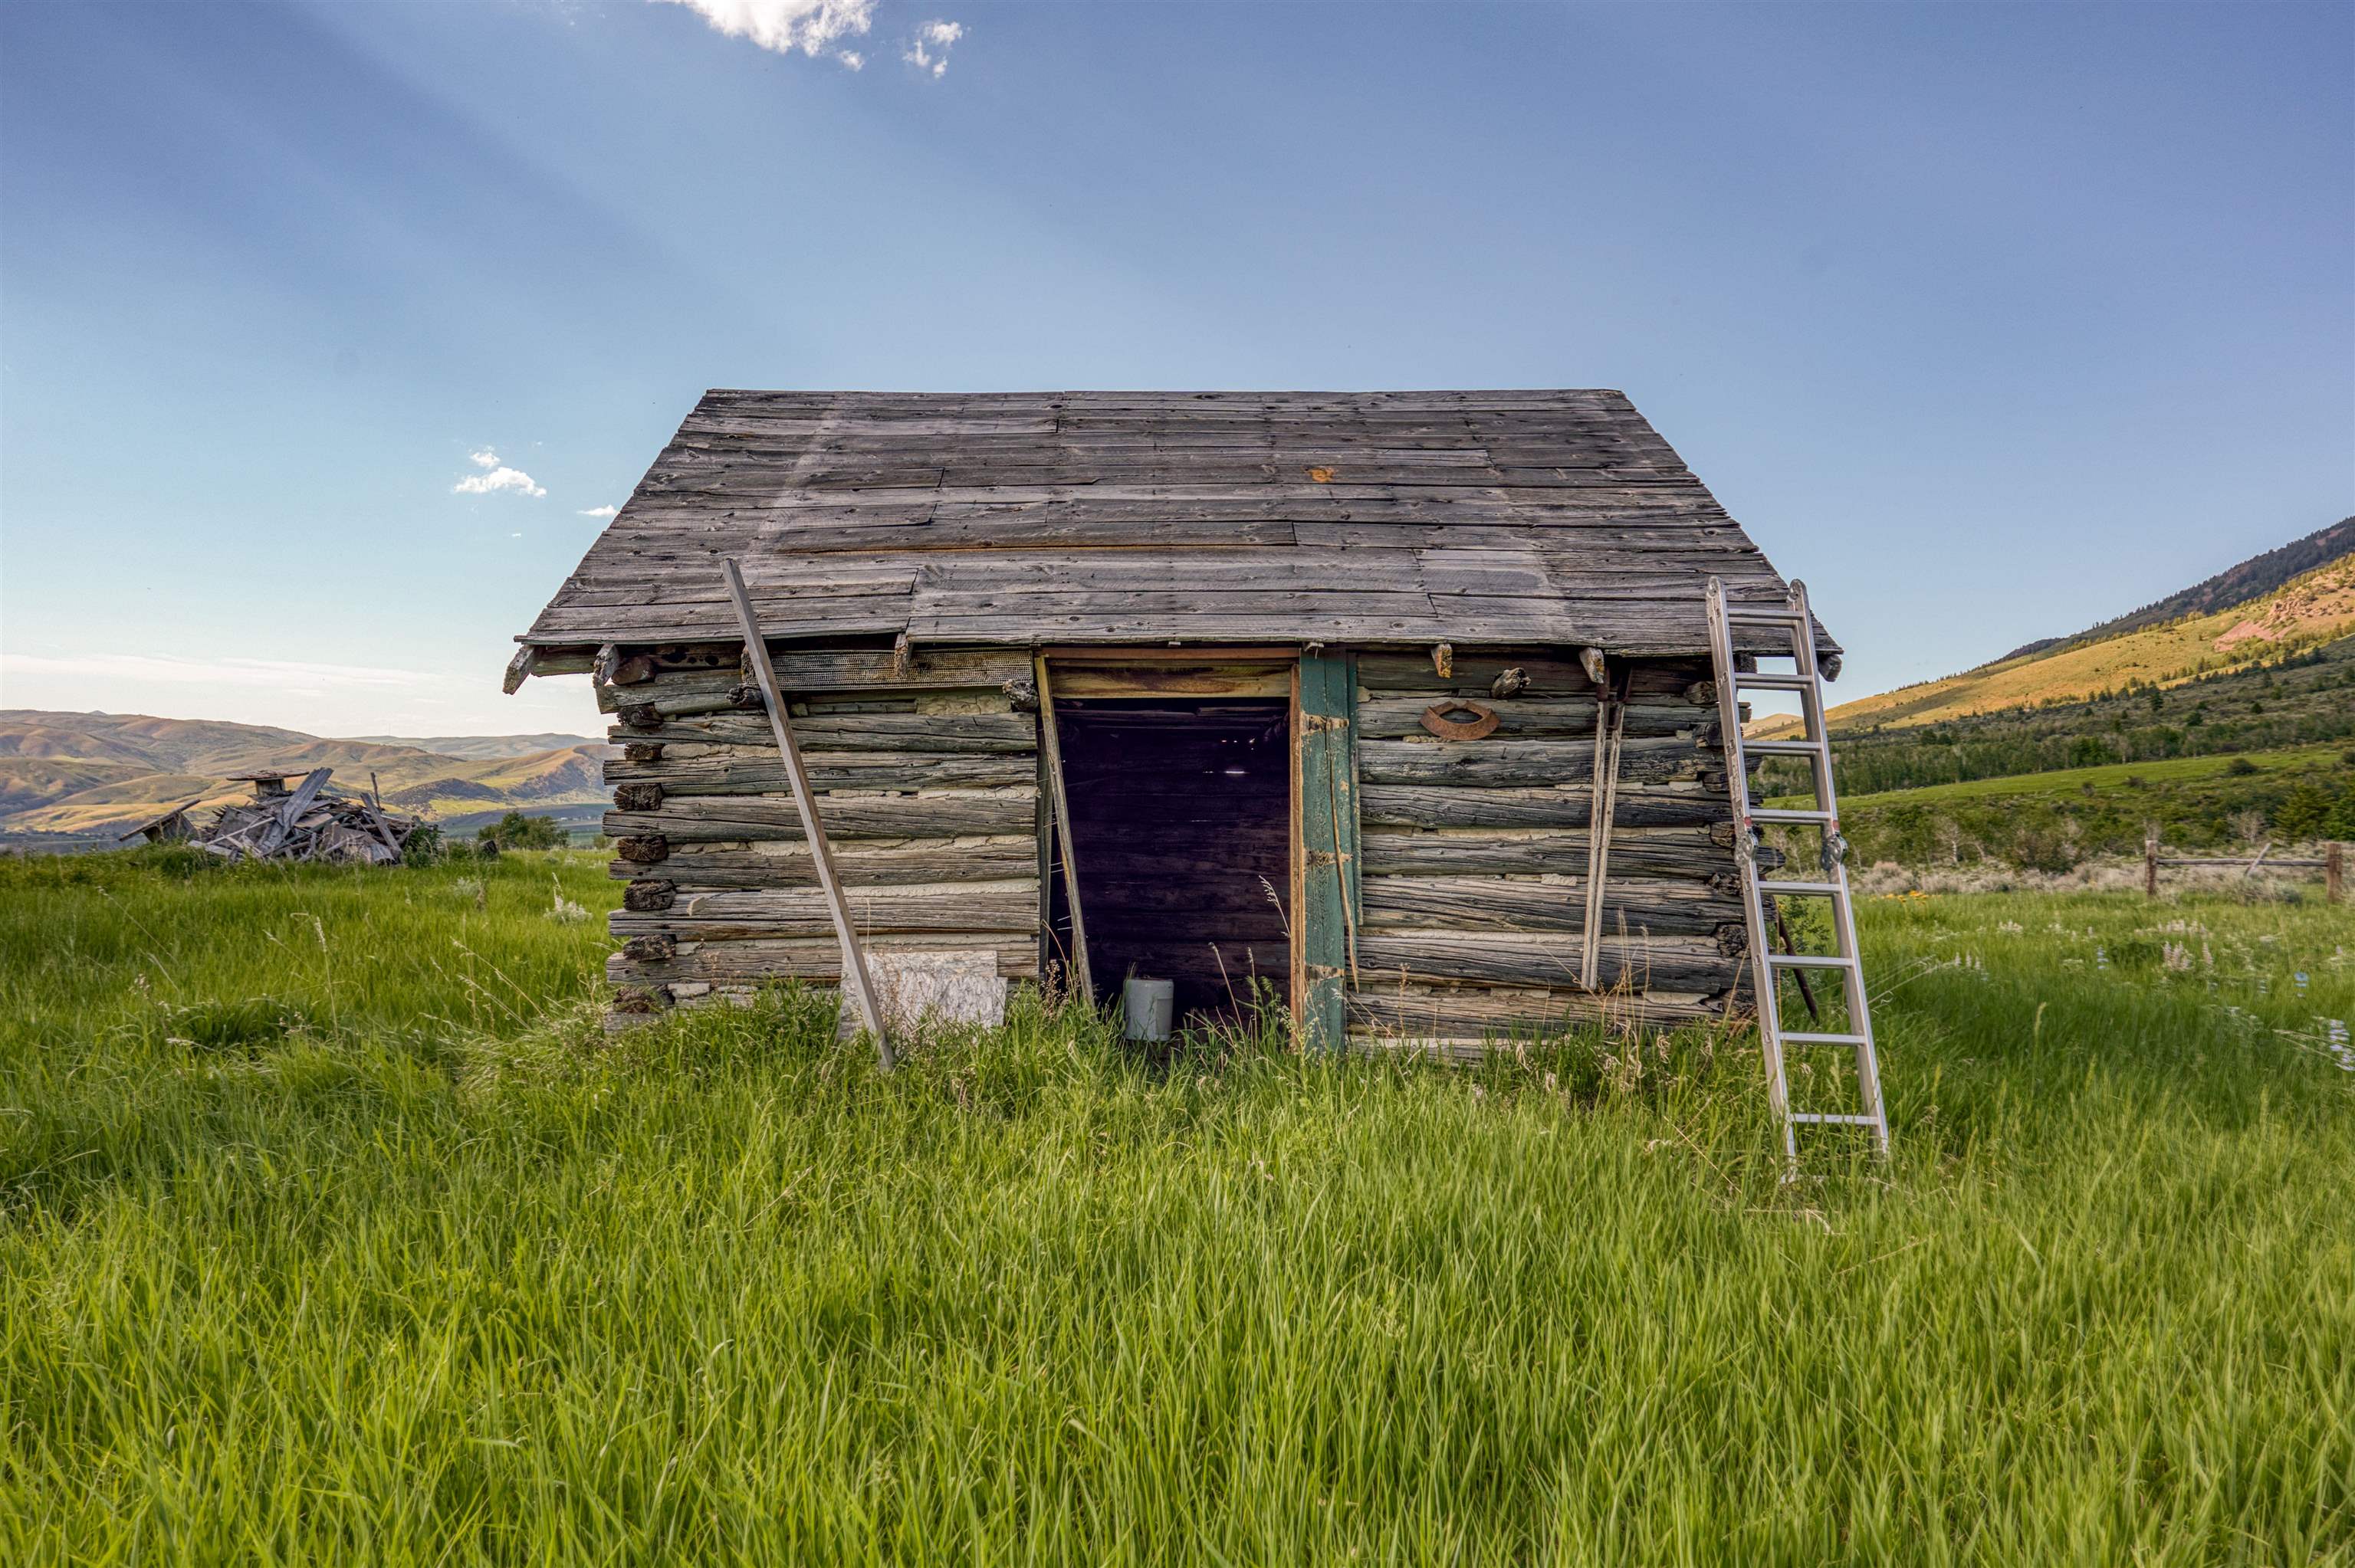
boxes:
[579,645,1742,1045]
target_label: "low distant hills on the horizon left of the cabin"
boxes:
[0,709,610,836]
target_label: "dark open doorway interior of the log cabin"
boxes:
[1050,697,1290,1022]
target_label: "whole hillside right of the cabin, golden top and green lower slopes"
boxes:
[1755,520,2355,871]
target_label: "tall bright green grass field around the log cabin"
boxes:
[0,855,2355,1563]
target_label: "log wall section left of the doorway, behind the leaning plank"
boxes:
[596,648,1041,1012]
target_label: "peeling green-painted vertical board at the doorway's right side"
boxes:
[1293,650,1361,1050]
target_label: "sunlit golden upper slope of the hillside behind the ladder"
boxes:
[1757,532,2355,734]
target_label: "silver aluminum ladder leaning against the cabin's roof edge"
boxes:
[1707,577,1889,1168]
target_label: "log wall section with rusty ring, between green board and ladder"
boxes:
[1349,652,1745,1045]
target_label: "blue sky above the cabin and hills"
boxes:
[0,0,2355,734]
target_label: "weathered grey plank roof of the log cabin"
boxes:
[521,391,1832,654]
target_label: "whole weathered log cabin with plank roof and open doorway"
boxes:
[509,391,1839,1045]
